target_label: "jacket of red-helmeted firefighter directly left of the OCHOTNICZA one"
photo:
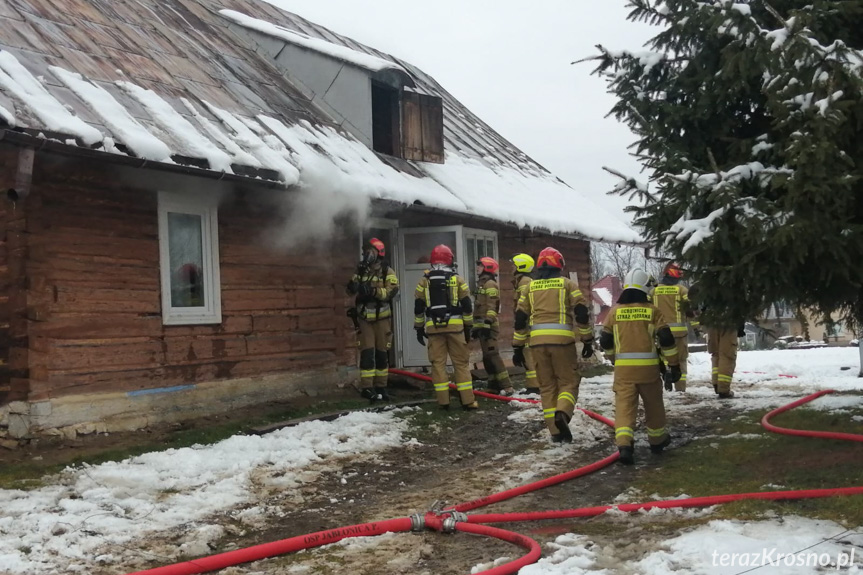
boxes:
[512,277,593,347]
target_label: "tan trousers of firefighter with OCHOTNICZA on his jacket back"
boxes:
[612,379,668,447]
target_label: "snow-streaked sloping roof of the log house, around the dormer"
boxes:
[0,0,639,242]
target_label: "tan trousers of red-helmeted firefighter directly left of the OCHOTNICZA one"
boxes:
[531,343,581,435]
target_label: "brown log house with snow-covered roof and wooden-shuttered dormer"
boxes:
[0,0,638,437]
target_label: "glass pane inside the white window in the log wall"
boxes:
[168,212,205,307]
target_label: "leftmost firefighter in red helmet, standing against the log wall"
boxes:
[348,238,399,402]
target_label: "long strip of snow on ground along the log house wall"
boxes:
[0,410,416,574]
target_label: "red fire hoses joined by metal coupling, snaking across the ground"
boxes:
[125,369,863,575]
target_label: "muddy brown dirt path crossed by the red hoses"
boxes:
[111,388,732,575]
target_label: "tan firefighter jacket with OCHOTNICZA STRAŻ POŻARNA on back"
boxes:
[599,302,679,384]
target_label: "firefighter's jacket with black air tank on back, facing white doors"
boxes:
[414,268,473,335]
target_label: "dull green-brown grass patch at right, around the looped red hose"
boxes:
[633,409,863,525]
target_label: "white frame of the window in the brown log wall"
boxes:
[159,192,222,325]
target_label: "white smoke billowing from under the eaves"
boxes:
[266,155,371,250]
